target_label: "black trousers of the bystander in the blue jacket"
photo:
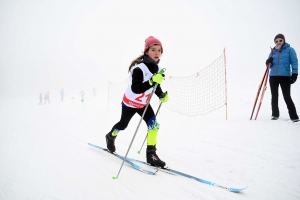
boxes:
[270,76,299,119]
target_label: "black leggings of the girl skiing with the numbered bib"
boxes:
[111,104,155,132]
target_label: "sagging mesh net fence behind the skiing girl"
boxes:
[108,50,227,117]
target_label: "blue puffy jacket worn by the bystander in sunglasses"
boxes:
[269,43,298,76]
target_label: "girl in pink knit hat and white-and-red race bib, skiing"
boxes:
[105,36,169,168]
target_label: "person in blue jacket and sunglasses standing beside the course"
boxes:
[266,33,299,122]
